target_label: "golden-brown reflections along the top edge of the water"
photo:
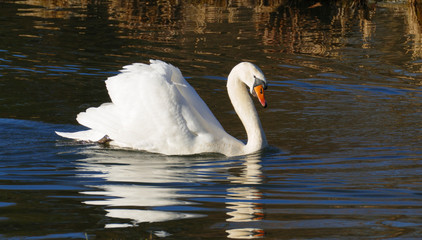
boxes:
[14,0,422,61]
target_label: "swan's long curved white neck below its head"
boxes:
[227,71,267,154]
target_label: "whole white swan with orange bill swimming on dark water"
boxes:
[56,60,267,156]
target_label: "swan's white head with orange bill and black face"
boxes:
[232,62,268,108]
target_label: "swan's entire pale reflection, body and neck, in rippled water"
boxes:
[78,148,264,238]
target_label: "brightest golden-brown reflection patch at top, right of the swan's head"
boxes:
[259,1,374,55]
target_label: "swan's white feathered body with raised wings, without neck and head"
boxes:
[61,60,243,155]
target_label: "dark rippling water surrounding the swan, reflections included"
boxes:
[0,0,422,239]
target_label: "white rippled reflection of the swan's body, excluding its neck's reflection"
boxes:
[80,150,203,227]
